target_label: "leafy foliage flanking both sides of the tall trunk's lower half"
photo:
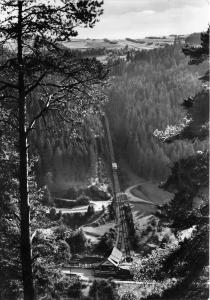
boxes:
[0,155,75,300]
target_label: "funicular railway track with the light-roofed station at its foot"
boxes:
[63,114,133,279]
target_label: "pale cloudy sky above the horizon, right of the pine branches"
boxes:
[78,0,210,39]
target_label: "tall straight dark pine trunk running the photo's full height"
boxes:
[18,0,34,300]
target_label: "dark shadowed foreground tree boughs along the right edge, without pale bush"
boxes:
[152,28,209,299]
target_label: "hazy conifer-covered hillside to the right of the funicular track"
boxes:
[106,44,206,180]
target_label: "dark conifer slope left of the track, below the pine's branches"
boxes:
[32,116,100,192]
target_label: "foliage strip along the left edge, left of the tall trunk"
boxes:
[0,134,21,299]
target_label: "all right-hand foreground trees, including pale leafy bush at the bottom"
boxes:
[130,28,209,300]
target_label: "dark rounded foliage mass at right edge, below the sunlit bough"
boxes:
[157,151,209,230]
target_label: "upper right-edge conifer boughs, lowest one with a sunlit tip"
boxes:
[155,27,209,143]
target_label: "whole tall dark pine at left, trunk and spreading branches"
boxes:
[0,0,106,300]
